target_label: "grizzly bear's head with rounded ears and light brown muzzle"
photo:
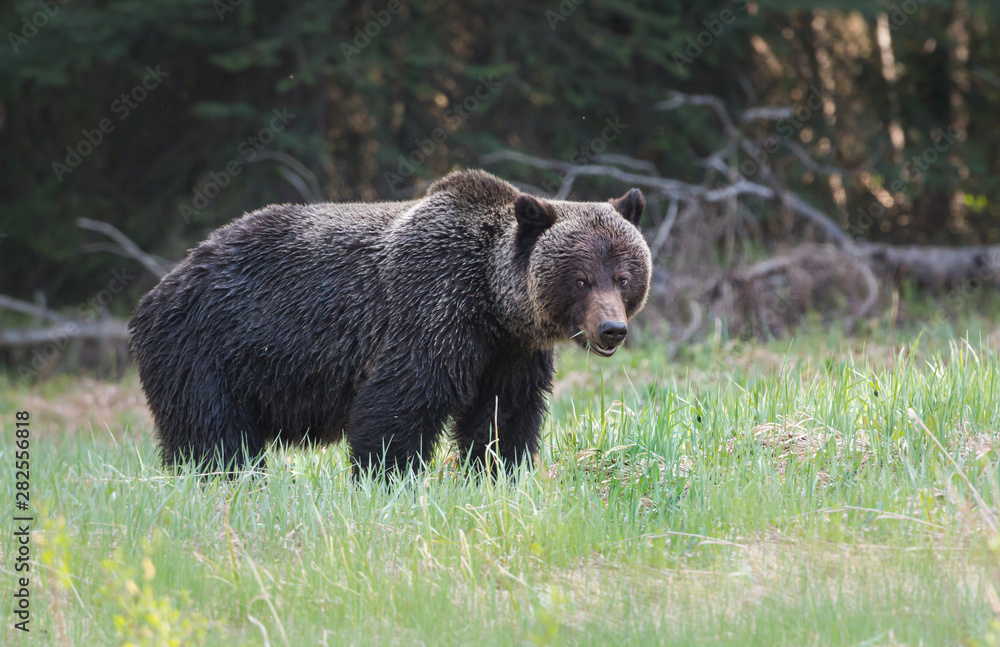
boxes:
[514,189,652,357]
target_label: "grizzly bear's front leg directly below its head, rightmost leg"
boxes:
[455,350,553,473]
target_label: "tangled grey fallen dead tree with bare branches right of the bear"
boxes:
[482,90,1000,335]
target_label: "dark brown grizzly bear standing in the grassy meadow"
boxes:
[129,171,651,473]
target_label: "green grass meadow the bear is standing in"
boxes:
[0,328,1000,646]
